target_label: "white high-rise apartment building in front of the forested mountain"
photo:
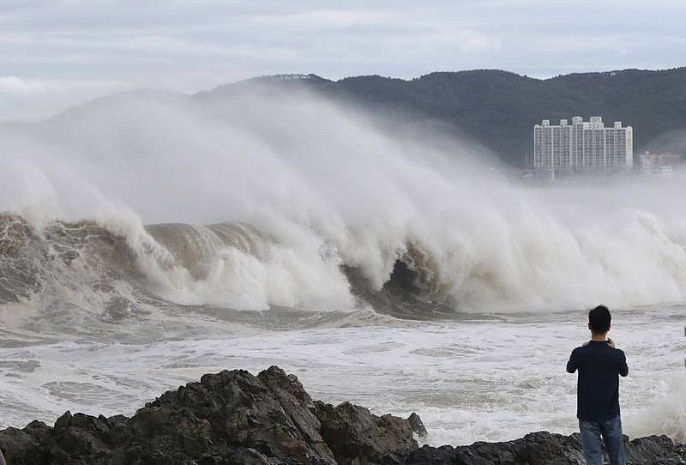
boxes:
[534,116,634,171]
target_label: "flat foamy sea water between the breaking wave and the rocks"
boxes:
[0,305,686,445]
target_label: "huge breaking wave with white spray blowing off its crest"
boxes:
[0,83,686,324]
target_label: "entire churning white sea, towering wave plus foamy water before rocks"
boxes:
[0,85,686,444]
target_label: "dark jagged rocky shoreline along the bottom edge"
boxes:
[0,367,686,465]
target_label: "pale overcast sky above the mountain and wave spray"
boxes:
[0,0,686,121]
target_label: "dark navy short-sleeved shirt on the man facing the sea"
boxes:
[567,341,629,422]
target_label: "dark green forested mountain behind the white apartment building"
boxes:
[213,68,686,166]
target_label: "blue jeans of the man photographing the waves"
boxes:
[579,415,626,465]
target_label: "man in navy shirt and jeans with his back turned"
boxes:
[567,305,629,465]
